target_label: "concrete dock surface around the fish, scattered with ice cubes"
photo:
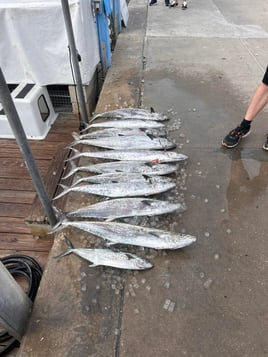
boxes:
[19,0,268,357]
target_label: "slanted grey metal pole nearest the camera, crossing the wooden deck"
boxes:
[0,67,57,227]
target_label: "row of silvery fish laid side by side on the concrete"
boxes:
[51,108,196,269]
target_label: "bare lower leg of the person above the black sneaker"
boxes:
[245,83,268,121]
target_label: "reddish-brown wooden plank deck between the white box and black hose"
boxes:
[0,115,79,266]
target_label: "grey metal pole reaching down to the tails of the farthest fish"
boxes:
[61,0,88,126]
